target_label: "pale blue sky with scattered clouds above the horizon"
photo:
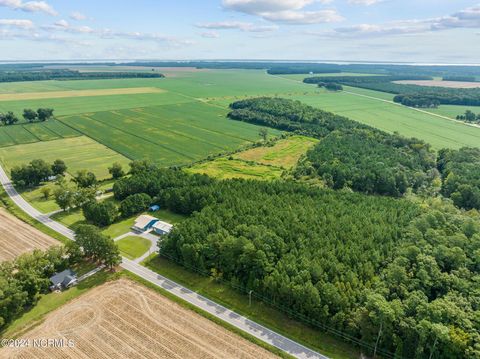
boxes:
[0,0,480,64]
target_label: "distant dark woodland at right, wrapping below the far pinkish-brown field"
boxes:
[303,76,480,107]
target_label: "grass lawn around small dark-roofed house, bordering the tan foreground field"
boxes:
[0,265,118,339]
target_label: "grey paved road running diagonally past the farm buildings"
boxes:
[0,166,328,359]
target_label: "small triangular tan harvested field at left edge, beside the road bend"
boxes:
[0,208,59,262]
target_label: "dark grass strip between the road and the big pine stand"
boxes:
[143,255,360,359]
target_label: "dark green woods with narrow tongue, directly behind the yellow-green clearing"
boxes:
[228,98,438,196]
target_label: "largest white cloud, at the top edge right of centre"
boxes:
[222,0,343,25]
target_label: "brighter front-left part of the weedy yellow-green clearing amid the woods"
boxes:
[185,157,283,181]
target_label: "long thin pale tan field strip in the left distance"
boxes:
[0,87,165,101]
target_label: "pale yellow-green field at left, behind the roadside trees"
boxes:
[0,136,130,179]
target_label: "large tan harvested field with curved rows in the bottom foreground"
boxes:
[0,280,275,359]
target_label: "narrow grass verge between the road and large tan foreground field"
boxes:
[121,271,293,358]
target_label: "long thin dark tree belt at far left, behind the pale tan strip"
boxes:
[0,70,164,82]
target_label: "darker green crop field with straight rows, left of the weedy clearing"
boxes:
[60,102,280,166]
